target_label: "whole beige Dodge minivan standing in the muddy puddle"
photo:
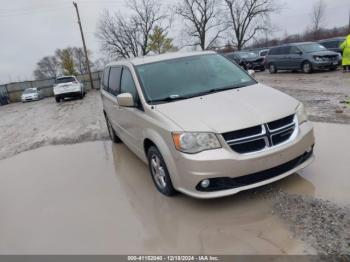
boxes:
[101,51,314,198]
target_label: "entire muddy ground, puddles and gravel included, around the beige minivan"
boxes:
[0,71,350,255]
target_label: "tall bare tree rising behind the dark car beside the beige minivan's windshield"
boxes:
[224,0,278,50]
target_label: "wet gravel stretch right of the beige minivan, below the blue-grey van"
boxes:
[256,70,350,124]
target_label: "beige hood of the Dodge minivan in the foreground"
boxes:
[155,84,299,133]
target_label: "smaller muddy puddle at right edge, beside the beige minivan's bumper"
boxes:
[278,123,350,207]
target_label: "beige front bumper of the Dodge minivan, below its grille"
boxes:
[169,122,315,198]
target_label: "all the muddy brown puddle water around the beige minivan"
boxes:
[0,123,350,254]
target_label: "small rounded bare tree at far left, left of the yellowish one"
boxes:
[34,56,61,80]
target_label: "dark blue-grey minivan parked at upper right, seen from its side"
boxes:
[266,42,339,73]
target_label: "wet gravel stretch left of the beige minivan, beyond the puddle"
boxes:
[0,91,108,162]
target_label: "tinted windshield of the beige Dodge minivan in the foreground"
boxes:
[136,54,256,102]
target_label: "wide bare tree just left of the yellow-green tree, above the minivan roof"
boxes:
[96,0,166,58]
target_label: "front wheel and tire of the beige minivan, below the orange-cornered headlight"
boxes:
[147,146,177,197]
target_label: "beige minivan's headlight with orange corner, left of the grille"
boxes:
[172,133,221,154]
